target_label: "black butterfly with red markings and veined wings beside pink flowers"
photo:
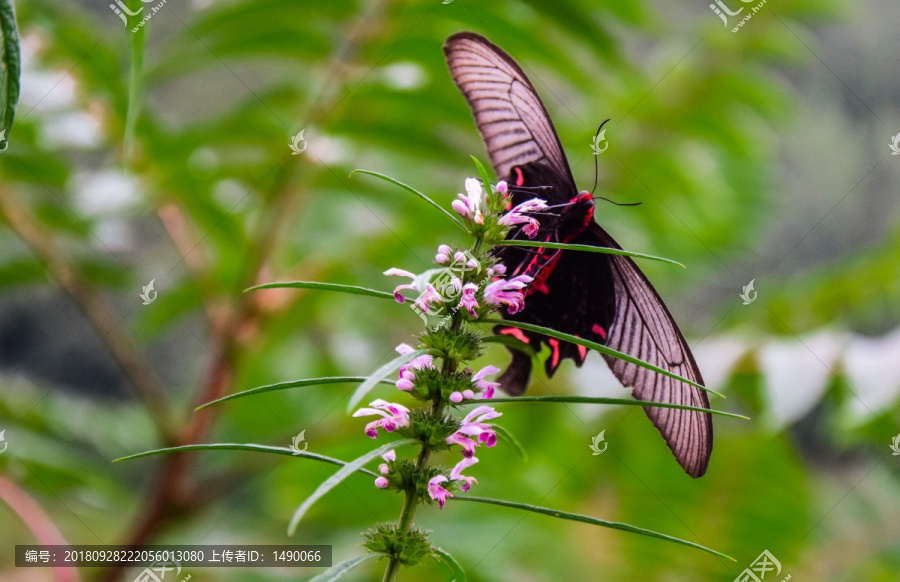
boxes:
[444,32,713,477]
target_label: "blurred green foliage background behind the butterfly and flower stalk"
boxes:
[0,0,900,582]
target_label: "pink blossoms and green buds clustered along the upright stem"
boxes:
[353,173,547,520]
